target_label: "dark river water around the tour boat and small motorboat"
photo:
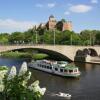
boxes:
[0,58,100,100]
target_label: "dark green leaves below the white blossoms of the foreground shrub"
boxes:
[4,71,42,100]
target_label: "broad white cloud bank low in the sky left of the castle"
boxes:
[0,19,36,32]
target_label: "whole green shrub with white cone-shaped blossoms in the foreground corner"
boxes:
[0,62,46,100]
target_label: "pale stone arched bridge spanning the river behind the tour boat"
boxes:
[0,45,100,61]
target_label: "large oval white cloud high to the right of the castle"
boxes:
[69,4,92,13]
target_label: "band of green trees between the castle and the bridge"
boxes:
[0,27,100,45]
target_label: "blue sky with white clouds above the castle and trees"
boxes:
[0,0,100,33]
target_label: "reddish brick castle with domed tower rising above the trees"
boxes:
[37,15,72,31]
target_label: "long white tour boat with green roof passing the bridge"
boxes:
[29,60,80,77]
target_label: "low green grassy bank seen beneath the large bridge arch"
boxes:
[1,51,48,60]
